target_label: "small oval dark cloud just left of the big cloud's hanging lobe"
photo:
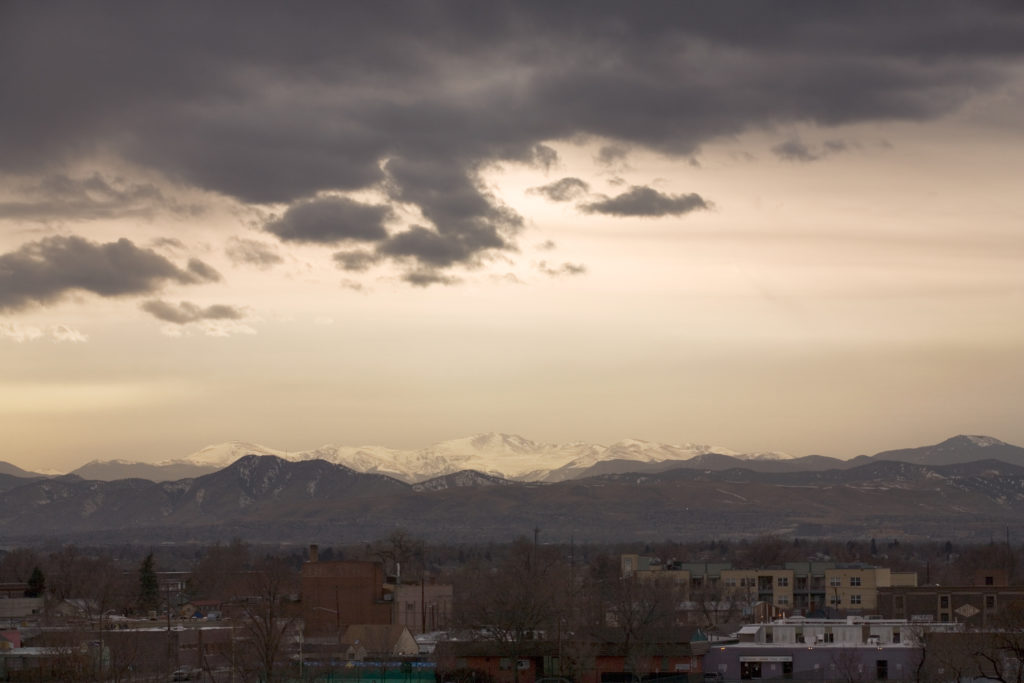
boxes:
[264,197,391,245]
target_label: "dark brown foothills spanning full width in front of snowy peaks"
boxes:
[0,436,1024,545]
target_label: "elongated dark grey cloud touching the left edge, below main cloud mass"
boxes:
[0,236,219,310]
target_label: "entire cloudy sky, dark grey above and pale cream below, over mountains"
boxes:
[0,0,1024,471]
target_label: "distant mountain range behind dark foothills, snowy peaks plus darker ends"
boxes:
[39,433,1024,483]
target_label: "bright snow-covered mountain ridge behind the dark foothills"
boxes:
[161,432,774,483]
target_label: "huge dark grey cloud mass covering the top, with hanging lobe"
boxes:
[6,0,1024,280]
